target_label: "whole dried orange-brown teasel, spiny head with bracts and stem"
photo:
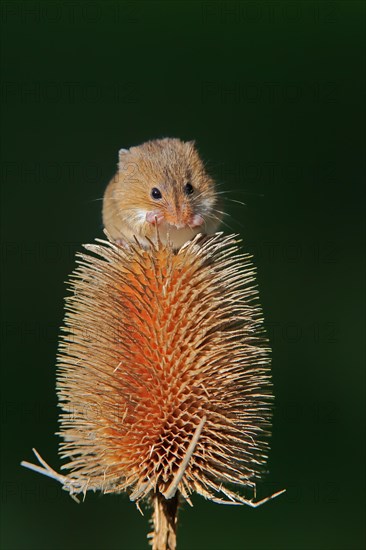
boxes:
[23,233,280,550]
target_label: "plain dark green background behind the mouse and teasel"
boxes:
[1,0,365,550]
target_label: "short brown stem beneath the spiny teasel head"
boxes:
[149,493,179,550]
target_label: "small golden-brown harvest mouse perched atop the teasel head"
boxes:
[103,138,222,249]
